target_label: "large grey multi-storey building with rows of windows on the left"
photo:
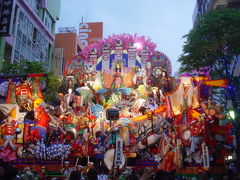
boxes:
[0,0,61,70]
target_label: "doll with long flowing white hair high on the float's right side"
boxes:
[167,76,199,124]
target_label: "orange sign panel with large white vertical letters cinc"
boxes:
[79,22,103,47]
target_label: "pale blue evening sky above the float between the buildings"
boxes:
[56,0,196,73]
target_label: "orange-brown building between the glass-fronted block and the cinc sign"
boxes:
[54,27,84,76]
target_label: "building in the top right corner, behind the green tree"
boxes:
[192,0,240,26]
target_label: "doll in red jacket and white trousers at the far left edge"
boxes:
[0,108,17,150]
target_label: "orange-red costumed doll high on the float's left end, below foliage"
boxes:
[15,79,33,111]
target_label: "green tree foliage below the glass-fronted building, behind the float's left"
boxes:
[0,60,60,103]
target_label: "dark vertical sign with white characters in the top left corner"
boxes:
[0,0,15,37]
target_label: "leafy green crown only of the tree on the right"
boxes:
[179,9,240,75]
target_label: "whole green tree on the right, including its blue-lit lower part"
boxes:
[178,9,240,118]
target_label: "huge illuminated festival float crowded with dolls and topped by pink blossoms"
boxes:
[0,34,234,179]
